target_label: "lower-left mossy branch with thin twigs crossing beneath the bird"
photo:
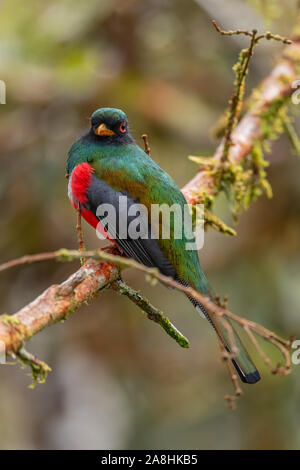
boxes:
[0,249,291,402]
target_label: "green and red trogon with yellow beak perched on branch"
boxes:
[67,108,260,384]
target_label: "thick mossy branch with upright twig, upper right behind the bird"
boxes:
[182,19,300,217]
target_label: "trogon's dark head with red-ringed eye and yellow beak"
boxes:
[91,108,128,142]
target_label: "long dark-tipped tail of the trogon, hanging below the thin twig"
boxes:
[181,282,260,384]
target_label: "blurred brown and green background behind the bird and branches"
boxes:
[0,0,300,449]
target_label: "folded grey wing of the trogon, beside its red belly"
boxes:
[85,174,176,277]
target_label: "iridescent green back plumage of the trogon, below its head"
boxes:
[68,141,209,294]
